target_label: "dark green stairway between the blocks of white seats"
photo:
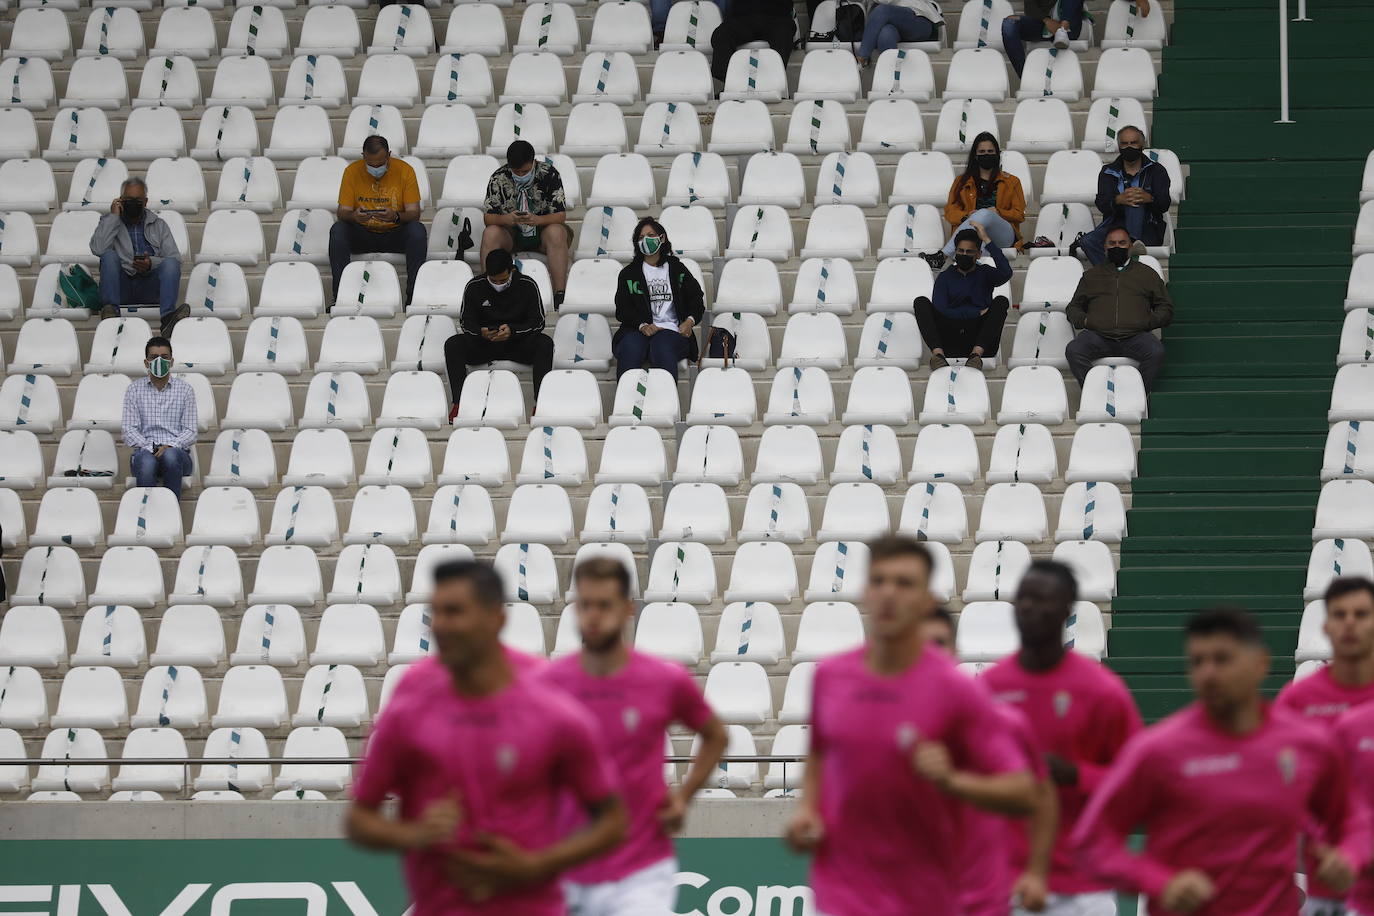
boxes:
[1109,0,1374,720]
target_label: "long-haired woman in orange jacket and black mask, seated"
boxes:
[921,130,1026,271]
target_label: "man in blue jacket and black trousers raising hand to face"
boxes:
[915,222,1011,369]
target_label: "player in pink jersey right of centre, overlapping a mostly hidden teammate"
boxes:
[787,536,1036,916]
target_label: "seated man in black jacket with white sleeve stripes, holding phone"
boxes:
[444,249,554,420]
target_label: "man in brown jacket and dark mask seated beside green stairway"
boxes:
[1063,227,1173,393]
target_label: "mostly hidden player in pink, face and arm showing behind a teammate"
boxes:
[926,607,1058,916]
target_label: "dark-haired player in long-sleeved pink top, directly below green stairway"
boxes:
[1073,607,1367,916]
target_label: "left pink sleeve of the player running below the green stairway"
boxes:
[1070,737,1173,897]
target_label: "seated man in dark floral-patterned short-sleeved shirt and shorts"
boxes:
[482,140,573,312]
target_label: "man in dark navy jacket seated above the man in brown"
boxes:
[1069,126,1169,264]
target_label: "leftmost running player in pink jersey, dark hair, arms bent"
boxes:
[348,560,625,916]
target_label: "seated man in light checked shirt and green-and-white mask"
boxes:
[122,336,198,500]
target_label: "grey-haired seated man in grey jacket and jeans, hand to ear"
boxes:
[91,179,191,336]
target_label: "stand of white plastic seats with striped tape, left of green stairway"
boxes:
[0,0,1181,798]
